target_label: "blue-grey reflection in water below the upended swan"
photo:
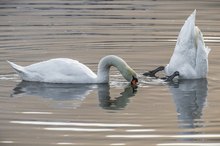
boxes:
[170,79,208,128]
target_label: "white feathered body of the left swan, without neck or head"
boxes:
[8,58,96,83]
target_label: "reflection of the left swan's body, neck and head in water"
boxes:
[12,81,136,109]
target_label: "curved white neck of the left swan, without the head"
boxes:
[97,55,128,83]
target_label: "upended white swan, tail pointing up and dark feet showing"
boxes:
[143,10,210,81]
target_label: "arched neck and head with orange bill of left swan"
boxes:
[98,55,138,85]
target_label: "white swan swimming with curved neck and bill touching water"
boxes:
[8,55,138,85]
